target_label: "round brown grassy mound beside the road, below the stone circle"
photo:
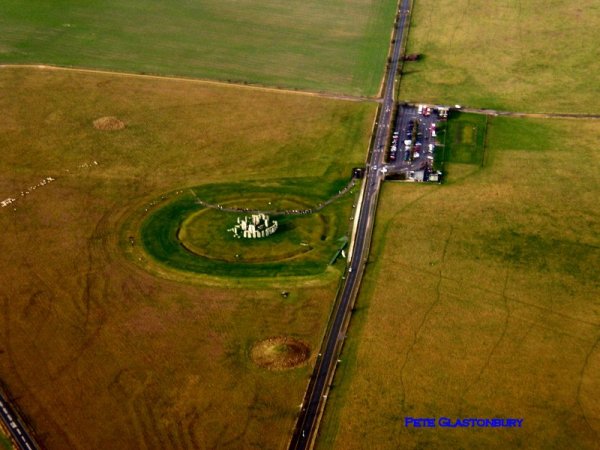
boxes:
[250,336,310,370]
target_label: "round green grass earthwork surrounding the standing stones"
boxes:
[131,178,355,281]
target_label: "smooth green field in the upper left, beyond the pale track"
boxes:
[0,0,396,95]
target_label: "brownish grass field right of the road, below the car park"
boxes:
[318,118,600,450]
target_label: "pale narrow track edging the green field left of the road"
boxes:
[0,64,381,103]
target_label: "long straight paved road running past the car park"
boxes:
[289,0,410,450]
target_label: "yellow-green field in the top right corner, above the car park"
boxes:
[400,0,600,114]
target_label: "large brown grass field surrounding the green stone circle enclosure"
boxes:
[0,69,375,450]
